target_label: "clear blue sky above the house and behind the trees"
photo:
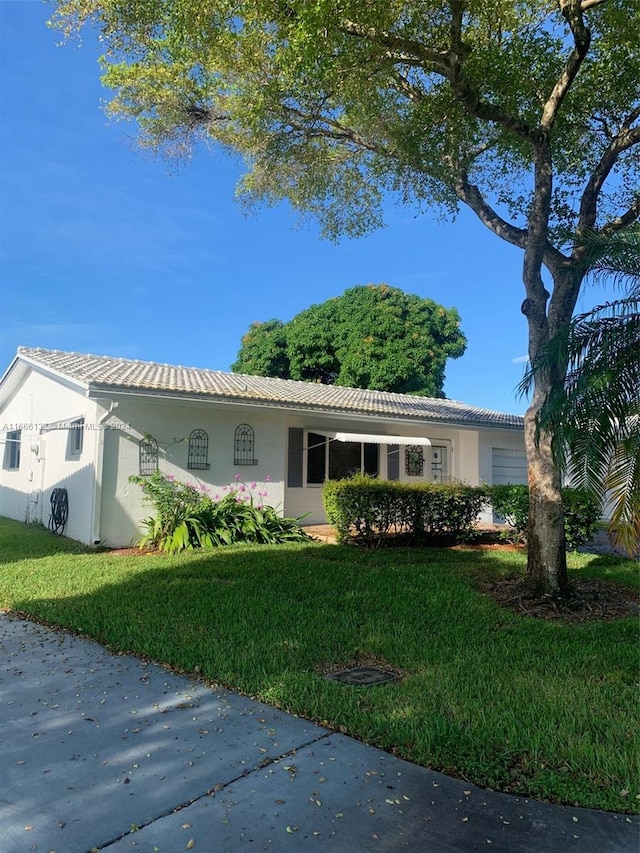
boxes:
[0,0,603,412]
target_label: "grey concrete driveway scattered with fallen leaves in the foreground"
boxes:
[0,615,640,853]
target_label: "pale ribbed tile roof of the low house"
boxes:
[18,347,523,429]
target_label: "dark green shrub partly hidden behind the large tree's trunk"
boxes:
[487,485,601,550]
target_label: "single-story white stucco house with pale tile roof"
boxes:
[0,347,526,547]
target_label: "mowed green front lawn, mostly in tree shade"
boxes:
[0,519,640,812]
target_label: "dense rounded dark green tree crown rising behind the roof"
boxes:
[232,284,466,397]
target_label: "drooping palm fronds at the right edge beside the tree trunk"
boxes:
[518,225,640,554]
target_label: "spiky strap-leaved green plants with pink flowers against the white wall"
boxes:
[129,471,309,554]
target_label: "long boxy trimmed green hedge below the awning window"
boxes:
[322,475,487,547]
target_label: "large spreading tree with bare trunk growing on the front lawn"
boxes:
[54,0,640,592]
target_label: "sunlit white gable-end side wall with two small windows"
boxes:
[0,371,99,543]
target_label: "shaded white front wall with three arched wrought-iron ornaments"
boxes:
[100,398,286,547]
